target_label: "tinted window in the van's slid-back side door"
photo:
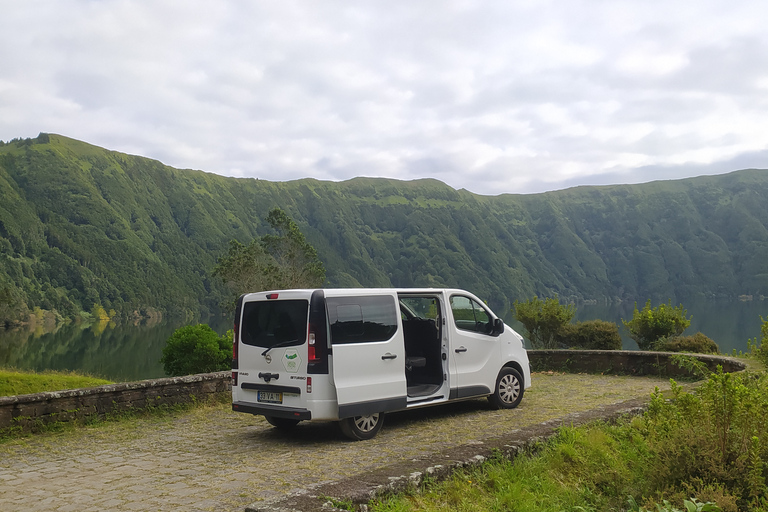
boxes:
[326,296,398,344]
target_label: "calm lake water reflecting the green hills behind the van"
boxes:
[0,300,768,382]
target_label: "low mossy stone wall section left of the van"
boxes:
[0,372,232,433]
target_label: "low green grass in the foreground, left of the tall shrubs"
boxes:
[372,425,644,512]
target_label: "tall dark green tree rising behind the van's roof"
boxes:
[213,208,325,296]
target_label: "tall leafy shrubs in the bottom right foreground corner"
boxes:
[642,369,768,510]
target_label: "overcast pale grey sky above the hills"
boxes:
[0,0,768,194]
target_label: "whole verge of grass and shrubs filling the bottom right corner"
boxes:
[369,364,768,512]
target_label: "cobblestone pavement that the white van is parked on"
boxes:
[0,373,669,512]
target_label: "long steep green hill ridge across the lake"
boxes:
[0,134,768,323]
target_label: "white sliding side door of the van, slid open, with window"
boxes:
[326,290,407,419]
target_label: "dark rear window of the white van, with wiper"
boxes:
[240,300,309,348]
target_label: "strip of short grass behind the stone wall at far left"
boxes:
[0,368,112,396]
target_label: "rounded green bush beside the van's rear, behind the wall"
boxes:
[160,324,232,377]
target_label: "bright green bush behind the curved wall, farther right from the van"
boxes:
[622,299,691,350]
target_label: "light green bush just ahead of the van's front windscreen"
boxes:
[514,296,576,348]
